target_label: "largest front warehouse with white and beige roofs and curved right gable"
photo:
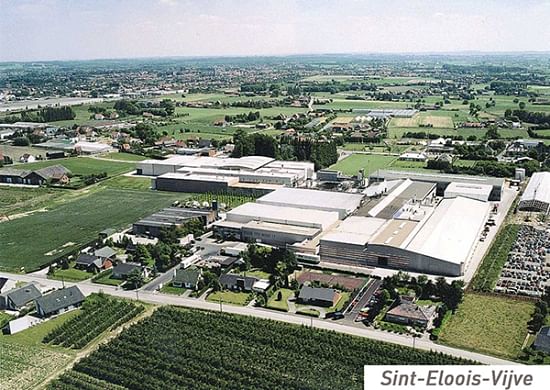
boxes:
[319,196,491,276]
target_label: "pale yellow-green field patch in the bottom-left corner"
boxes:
[0,340,73,390]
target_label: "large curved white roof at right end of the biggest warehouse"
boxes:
[407,196,491,264]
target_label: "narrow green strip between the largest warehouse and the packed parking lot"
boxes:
[471,225,520,292]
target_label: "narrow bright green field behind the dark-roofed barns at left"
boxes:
[22,157,135,176]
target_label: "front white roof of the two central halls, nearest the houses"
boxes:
[226,203,338,229]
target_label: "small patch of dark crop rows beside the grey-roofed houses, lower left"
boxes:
[42,297,144,349]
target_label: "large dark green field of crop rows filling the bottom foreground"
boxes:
[52,307,471,390]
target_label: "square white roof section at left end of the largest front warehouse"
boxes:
[321,216,386,245]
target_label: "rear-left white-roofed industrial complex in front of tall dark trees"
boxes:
[140,156,315,192]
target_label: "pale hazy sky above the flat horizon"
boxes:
[0,0,550,61]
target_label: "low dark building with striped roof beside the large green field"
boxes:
[132,207,218,237]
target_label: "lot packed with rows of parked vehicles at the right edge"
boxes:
[495,225,550,297]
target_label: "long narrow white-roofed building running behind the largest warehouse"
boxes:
[369,169,504,201]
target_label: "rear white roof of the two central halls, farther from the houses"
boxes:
[257,188,363,217]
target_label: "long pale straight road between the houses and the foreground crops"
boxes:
[0,272,516,365]
